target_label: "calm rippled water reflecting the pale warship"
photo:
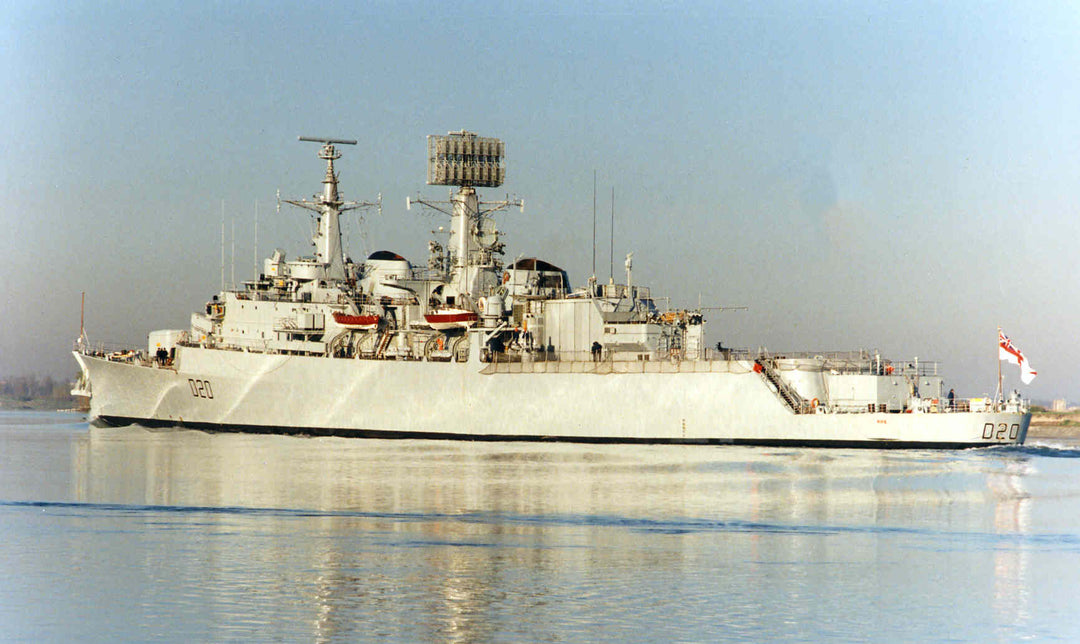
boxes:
[0,412,1080,642]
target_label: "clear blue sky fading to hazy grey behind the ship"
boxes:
[0,0,1080,402]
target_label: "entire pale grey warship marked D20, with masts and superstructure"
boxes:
[73,131,1030,448]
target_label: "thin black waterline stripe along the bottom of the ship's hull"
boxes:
[93,416,1009,450]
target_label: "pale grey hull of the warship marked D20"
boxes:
[76,347,1030,450]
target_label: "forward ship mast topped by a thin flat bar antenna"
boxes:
[284,136,380,281]
